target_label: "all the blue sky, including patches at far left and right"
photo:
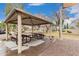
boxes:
[0,3,75,21]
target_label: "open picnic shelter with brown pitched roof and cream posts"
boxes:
[5,8,52,54]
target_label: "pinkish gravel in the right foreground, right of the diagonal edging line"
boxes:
[40,40,79,56]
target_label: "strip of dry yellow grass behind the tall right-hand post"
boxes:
[44,31,79,40]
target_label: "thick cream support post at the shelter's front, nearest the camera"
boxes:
[17,14,22,54]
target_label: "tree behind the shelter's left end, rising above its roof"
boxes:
[5,3,24,30]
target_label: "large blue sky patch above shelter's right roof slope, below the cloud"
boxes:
[25,3,60,16]
